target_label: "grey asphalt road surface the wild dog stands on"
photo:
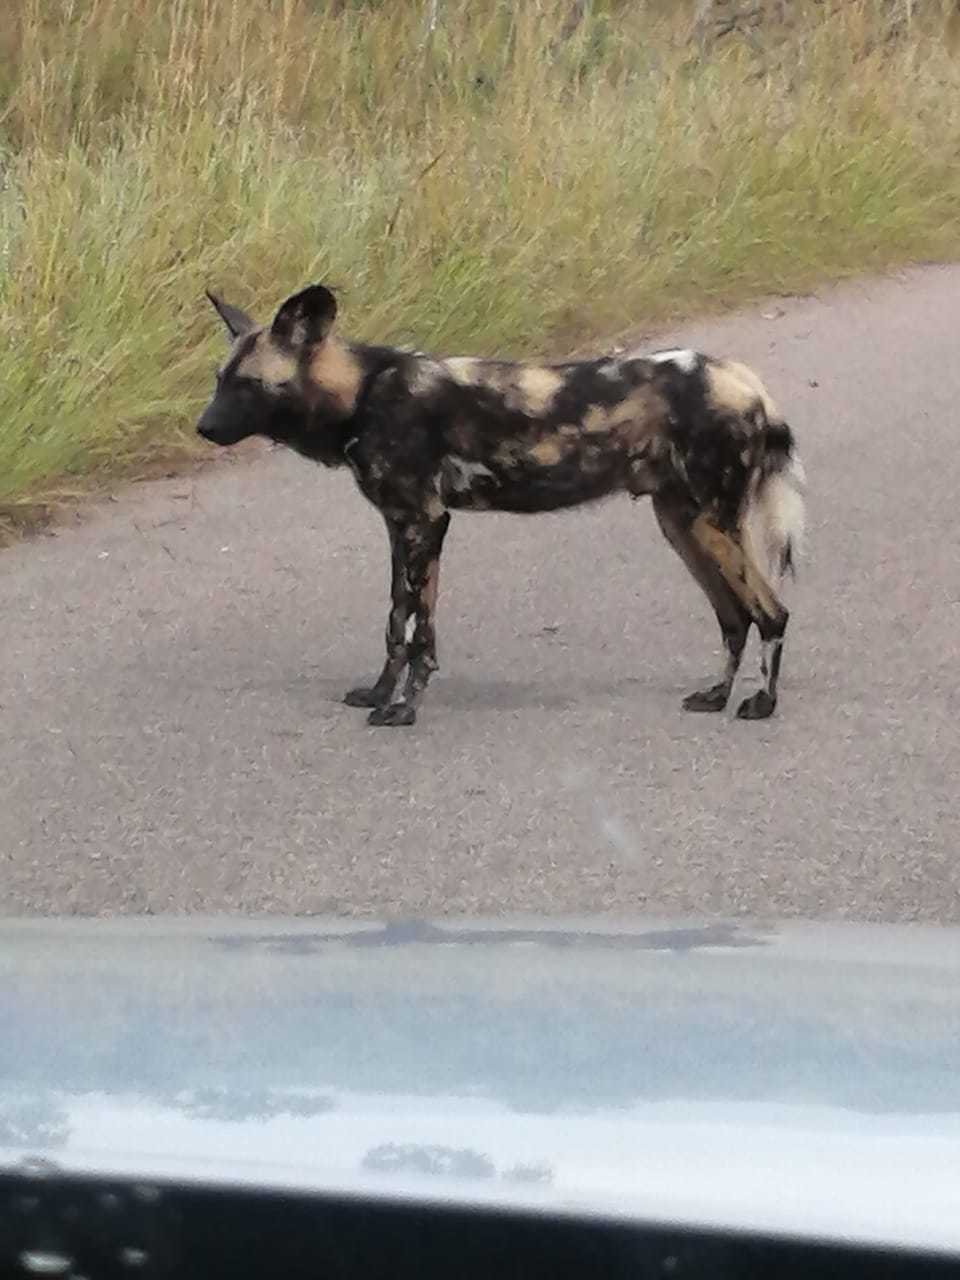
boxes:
[0,268,960,922]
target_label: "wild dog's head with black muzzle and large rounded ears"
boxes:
[197,284,362,461]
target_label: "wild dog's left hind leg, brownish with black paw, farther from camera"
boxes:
[653,492,751,712]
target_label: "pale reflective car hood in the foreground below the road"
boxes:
[0,918,960,1253]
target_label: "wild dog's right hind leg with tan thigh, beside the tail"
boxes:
[692,515,790,719]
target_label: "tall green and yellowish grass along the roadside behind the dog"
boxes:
[0,0,960,526]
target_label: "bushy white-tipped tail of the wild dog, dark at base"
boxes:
[745,420,806,581]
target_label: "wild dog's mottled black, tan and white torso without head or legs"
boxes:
[365,351,798,527]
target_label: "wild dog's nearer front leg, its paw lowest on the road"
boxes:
[370,512,451,724]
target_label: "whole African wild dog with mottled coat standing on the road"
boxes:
[198,284,803,724]
